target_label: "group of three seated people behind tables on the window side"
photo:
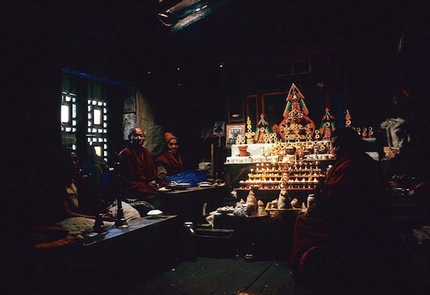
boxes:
[32,127,187,248]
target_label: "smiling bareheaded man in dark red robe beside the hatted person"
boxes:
[118,127,159,203]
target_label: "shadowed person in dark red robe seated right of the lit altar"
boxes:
[290,128,404,294]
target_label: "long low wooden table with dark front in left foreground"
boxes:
[31,215,184,294]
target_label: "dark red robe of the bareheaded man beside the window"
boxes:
[119,145,157,198]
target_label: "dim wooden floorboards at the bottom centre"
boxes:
[121,257,313,295]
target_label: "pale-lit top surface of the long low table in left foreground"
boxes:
[84,215,177,246]
